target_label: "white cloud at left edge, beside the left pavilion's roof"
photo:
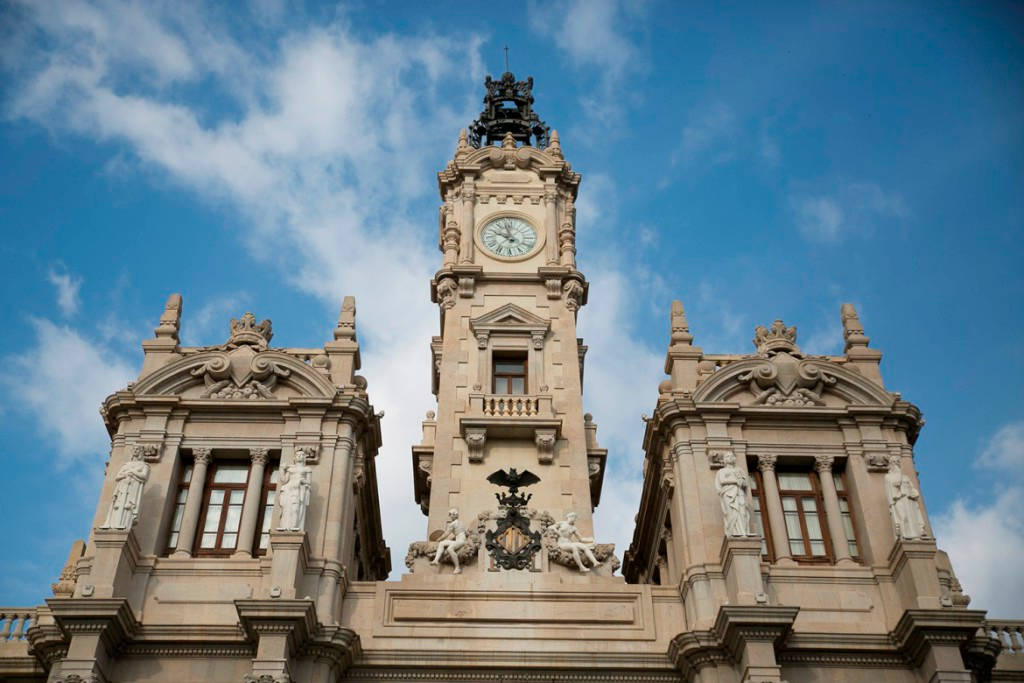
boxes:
[2,318,137,465]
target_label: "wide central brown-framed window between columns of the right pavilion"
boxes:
[777,472,831,562]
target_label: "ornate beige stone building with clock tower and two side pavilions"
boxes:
[0,74,1024,683]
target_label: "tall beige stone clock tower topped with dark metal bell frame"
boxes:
[408,73,617,573]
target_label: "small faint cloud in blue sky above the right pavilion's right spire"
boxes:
[790,181,911,244]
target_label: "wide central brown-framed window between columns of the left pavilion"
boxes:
[196,461,249,555]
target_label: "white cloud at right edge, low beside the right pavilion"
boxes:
[932,421,1024,618]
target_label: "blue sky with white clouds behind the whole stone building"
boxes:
[0,0,1024,616]
